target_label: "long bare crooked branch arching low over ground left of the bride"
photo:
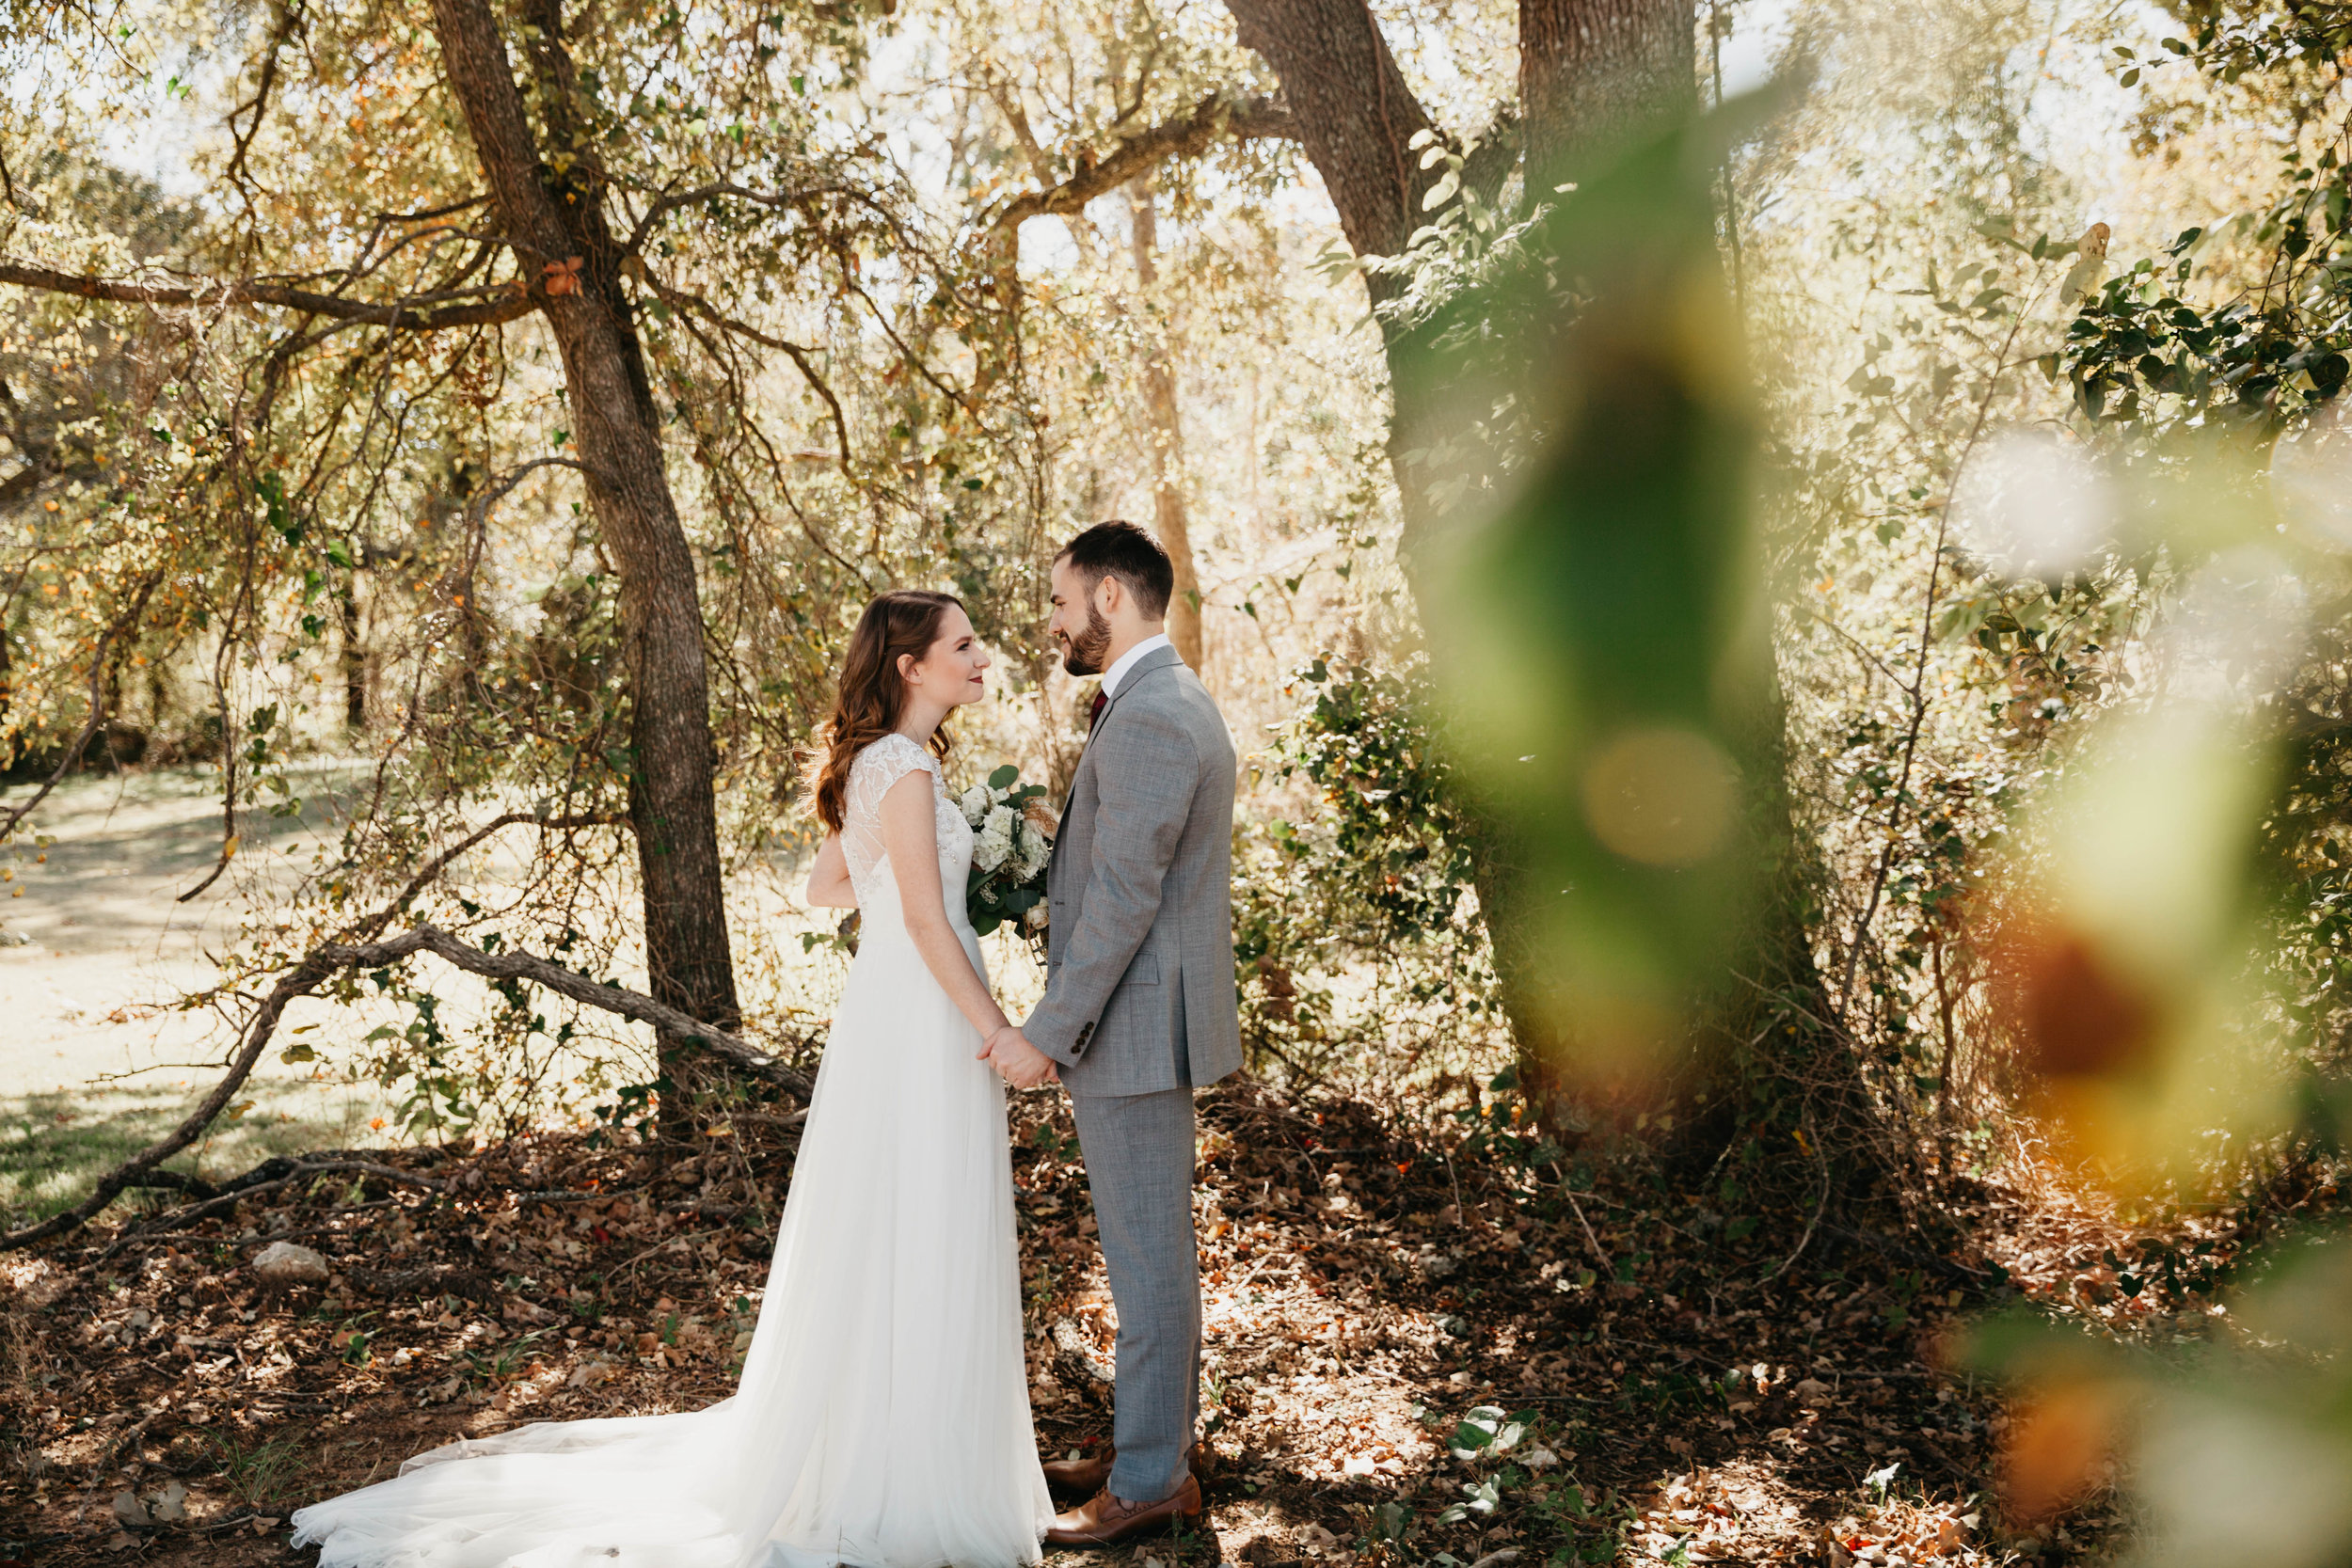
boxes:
[0,927,817,1253]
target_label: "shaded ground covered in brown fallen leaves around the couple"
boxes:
[0,1084,2070,1568]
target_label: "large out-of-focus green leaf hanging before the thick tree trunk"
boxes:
[1421,103,1786,1079]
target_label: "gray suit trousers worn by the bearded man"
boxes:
[1071,1088,1200,1502]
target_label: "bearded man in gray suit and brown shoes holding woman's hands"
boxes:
[986,522,1242,1547]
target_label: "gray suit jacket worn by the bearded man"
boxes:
[1021,649,1242,1096]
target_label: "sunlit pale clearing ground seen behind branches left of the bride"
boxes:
[0,759,889,1227]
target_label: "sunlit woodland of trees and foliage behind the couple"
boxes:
[13,0,2352,1561]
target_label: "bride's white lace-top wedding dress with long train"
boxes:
[294,736,1054,1568]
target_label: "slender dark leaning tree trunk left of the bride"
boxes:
[433,0,739,1133]
